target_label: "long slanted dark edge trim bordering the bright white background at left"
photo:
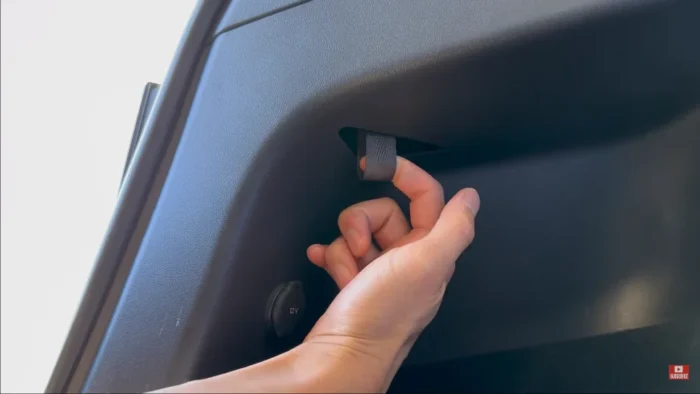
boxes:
[46,1,225,392]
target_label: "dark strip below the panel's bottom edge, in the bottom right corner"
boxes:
[389,321,700,393]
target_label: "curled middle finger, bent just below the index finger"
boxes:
[338,198,411,258]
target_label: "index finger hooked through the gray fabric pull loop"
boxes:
[360,156,445,230]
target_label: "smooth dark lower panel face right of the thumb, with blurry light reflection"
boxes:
[380,109,700,363]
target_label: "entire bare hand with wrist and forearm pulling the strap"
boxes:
[159,157,480,393]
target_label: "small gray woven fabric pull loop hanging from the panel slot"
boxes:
[357,130,396,182]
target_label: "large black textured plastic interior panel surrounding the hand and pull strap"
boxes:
[80,0,700,391]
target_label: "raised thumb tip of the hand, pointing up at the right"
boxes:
[421,188,481,263]
